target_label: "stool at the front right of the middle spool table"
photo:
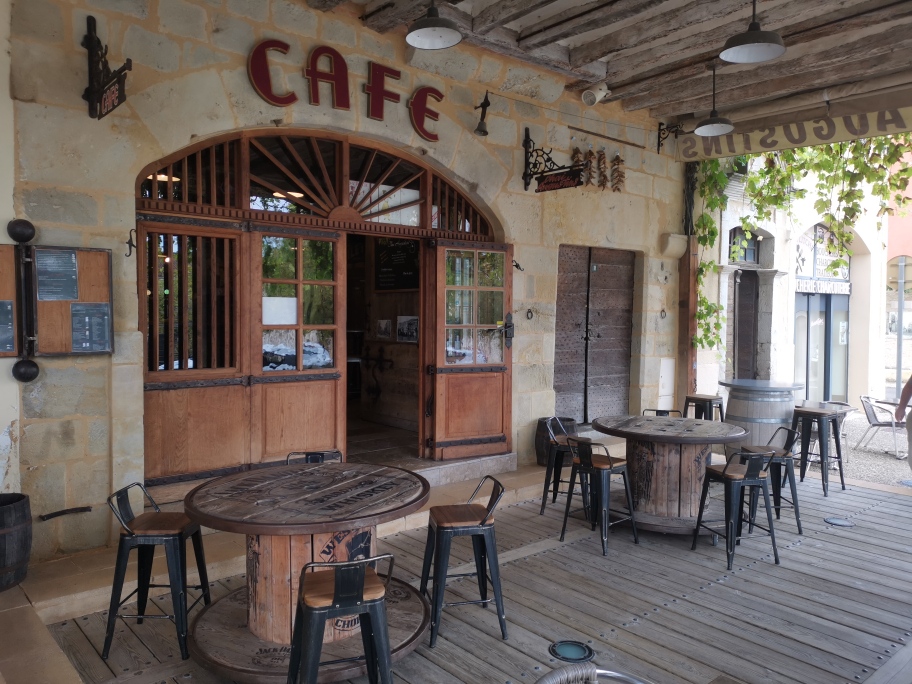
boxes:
[690,450,779,570]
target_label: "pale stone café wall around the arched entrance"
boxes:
[8,0,683,558]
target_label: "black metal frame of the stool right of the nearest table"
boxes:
[419,475,507,648]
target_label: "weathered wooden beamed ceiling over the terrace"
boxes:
[307,0,912,130]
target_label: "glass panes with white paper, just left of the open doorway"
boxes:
[261,235,336,373]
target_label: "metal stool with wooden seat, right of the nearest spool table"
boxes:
[420,475,507,648]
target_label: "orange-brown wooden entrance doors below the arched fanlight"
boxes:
[137,219,512,481]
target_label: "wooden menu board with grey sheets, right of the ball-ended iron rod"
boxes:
[30,247,114,356]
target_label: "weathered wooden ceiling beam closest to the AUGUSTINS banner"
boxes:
[649,37,912,118]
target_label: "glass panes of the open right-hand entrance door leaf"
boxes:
[445,250,505,365]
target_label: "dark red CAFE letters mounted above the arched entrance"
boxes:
[247,38,443,142]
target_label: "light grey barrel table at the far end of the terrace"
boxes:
[719,379,804,447]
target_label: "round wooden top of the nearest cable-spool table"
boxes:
[184,463,431,535]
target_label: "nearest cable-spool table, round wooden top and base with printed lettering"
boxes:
[184,463,431,684]
